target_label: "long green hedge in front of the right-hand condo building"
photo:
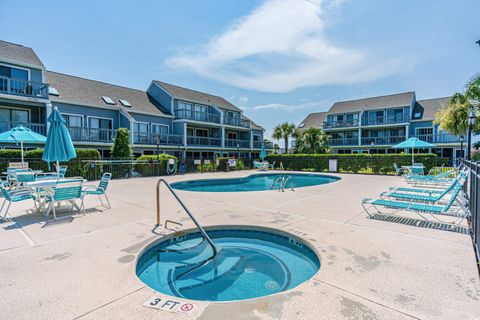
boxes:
[267,154,449,174]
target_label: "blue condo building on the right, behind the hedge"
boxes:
[299,92,466,161]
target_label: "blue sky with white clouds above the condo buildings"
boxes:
[0,0,480,139]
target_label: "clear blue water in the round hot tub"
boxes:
[136,229,320,301]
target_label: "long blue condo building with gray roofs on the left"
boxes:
[0,40,272,159]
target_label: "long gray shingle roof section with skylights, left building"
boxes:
[45,71,169,116]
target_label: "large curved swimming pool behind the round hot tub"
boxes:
[171,173,340,192]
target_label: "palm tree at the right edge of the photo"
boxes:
[434,74,480,135]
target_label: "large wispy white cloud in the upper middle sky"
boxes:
[166,0,412,92]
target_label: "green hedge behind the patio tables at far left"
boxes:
[0,149,101,176]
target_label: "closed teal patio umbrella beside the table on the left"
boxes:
[42,107,77,174]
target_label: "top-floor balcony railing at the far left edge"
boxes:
[0,76,48,99]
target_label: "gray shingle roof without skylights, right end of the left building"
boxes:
[154,80,242,112]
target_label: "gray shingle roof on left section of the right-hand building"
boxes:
[328,92,415,114]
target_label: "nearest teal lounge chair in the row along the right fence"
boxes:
[362,179,470,226]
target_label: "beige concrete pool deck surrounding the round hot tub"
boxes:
[0,172,480,320]
